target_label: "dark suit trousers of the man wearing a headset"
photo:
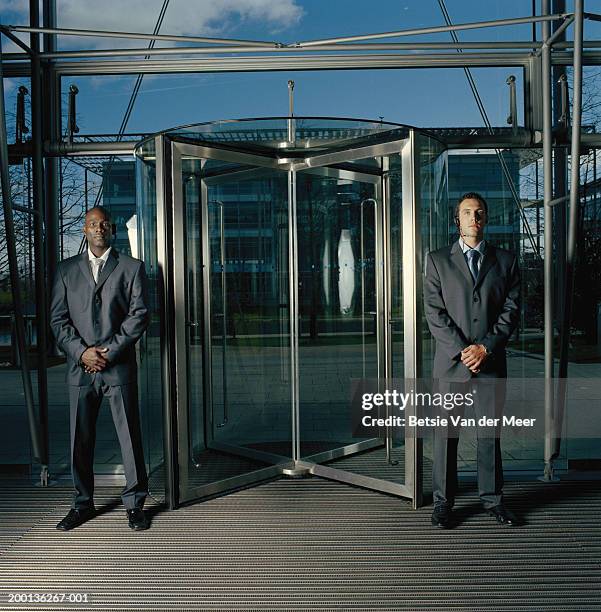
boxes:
[432,378,505,509]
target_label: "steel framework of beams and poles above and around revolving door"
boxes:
[0,0,601,481]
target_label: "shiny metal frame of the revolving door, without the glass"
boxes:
[155,128,423,508]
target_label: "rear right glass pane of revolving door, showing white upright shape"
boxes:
[296,169,381,461]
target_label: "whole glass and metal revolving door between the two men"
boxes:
[137,118,446,507]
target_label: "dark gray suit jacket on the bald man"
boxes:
[50,248,150,386]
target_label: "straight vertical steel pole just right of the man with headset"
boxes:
[541,0,554,482]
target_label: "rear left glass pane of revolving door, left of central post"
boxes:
[204,171,292,462]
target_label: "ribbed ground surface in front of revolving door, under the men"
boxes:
[0,478,601,612]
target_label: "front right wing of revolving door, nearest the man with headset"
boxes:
[297,156,414,495]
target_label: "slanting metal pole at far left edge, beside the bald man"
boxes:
[0,35,44,470]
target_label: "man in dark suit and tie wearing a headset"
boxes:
[424,193,520,528]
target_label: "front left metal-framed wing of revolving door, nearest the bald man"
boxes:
[172,144,291,503]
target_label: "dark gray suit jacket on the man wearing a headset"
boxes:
[424,241,520,381]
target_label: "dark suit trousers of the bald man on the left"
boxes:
[69,373,148,510]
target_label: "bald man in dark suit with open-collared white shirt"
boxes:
[50,206,149,531]
